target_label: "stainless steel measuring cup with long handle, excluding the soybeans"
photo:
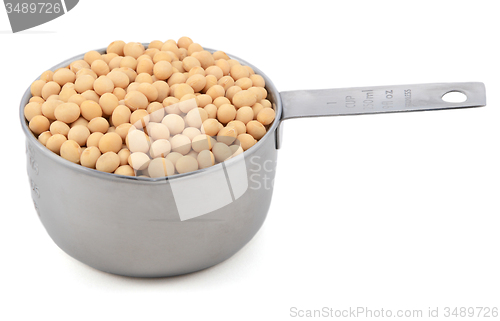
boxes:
[19,45,486,277]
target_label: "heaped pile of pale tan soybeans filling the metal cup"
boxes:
[24,37,276,178]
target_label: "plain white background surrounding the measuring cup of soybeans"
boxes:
[0,0,500,320]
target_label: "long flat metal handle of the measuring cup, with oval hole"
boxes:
[277,82,486,148]
